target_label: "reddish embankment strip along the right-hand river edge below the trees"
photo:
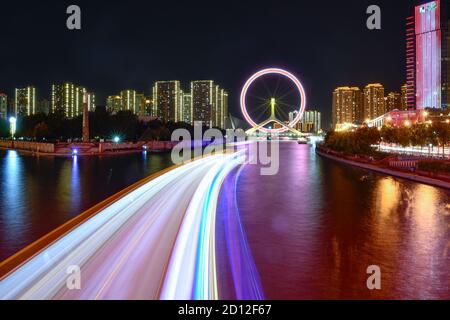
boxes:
[316,146,450,189]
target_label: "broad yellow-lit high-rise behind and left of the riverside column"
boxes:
[51,82,95,118]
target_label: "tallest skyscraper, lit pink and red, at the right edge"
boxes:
[406,0,450,110]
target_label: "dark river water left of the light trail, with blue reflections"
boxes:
[0,150,172,260]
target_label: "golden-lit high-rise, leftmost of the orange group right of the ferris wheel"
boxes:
[332,87,364,128]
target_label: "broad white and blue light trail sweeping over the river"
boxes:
[0,151,244,299]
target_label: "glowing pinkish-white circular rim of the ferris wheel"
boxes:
[241,68,306,133]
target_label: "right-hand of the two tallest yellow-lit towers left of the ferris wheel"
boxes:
[191,80,216,127]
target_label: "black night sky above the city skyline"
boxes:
[0,0,415,126]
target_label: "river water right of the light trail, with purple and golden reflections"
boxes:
[217,143,450,299]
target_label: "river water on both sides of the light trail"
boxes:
[0,143,450,299]
